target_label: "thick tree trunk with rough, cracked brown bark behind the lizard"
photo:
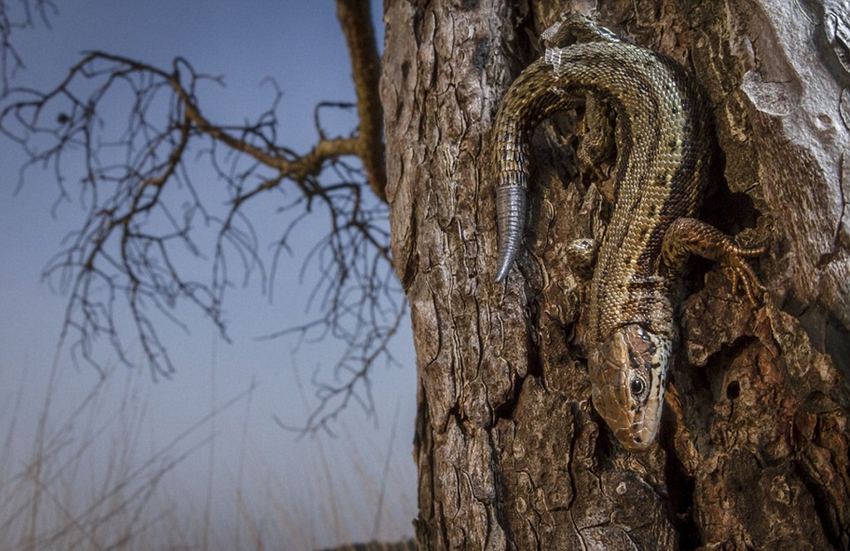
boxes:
[381,0,850,550]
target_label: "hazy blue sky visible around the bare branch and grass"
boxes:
[0,0,415,549]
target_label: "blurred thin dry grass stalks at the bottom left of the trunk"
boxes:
[0,360,414,551]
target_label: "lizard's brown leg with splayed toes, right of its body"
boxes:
[661,218,766,306]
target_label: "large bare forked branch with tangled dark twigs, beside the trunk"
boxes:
[0,0,398,425]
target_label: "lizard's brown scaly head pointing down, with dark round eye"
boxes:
[588,324,672,451]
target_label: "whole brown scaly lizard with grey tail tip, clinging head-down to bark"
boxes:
[491,13,765,452]
